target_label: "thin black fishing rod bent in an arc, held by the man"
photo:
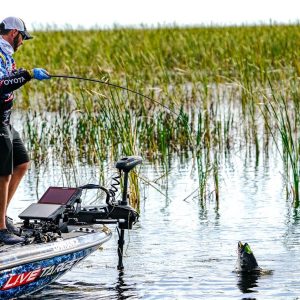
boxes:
[49,74,180,117]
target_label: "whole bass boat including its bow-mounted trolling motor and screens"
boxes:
[0,156,142,299]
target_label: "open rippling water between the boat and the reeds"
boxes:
[9,146,300,299]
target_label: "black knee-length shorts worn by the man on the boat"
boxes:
[0,125,29,176]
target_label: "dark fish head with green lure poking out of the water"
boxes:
[235,242,261,272]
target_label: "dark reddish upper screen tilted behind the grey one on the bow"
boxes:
[38,187,81,205]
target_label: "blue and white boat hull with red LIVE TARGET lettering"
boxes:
[0,232,111,299]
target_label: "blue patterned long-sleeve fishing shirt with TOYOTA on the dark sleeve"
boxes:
[0,35,32,127]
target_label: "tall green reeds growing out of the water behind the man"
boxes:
[11,25,300,206]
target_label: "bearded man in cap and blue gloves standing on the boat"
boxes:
[0,17,50,245]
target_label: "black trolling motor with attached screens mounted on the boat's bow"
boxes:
[19,156,142,270]
